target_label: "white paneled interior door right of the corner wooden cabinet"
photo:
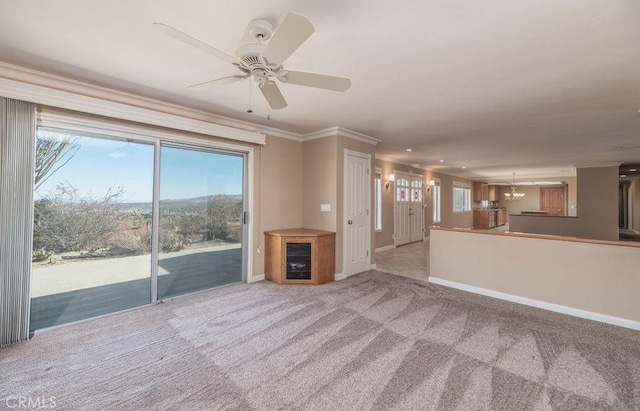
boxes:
[343,150,371,276]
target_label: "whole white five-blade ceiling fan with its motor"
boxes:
[153,13,351,110]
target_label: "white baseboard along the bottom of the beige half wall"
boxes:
[429,277,640,331]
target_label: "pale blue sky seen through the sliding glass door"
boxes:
[35,130,243,203]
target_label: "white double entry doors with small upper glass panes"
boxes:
[394,170,424,246]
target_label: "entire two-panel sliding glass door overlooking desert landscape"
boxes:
[30,128,246,331]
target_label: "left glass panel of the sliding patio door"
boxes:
[30,129,154,330]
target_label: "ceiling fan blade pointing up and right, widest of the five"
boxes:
[261,13,316,66]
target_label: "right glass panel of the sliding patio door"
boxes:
[158,145,244,299]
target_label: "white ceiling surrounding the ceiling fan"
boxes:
[0,0,640,180]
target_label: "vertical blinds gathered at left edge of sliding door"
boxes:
[0,97,36,346]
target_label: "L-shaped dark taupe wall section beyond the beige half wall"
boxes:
[509,166,619,241]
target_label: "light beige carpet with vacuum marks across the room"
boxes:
[0,271,640,410]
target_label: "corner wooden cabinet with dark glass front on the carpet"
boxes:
[264,228,336,284]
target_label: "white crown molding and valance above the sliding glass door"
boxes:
[0,62,272,145]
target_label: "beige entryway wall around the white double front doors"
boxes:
[375,159,473,248]
